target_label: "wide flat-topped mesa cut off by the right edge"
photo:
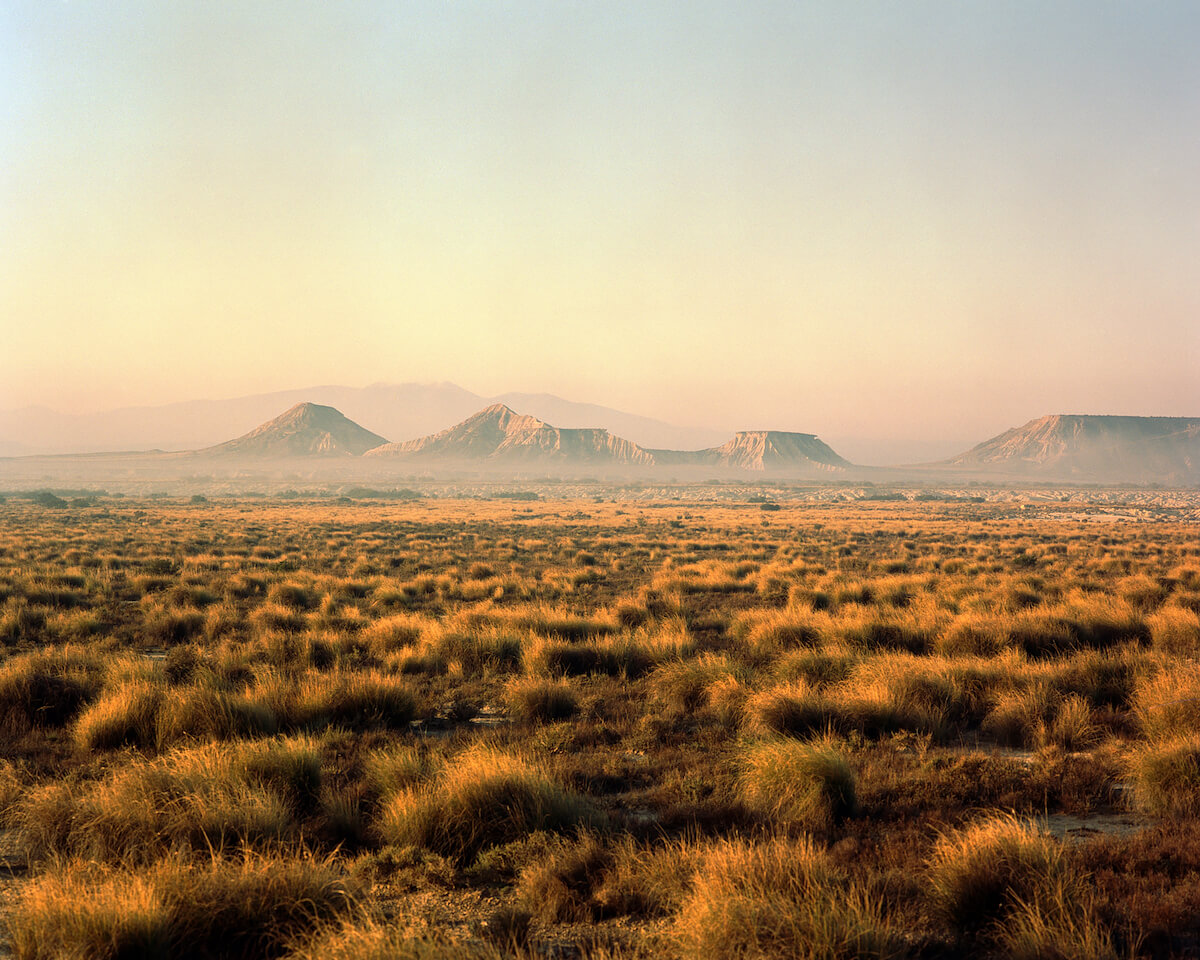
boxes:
[932,414,1200,484]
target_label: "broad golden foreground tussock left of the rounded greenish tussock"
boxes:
[378,746,599,864]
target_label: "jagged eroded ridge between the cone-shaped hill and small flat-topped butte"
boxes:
[367,403,654,467]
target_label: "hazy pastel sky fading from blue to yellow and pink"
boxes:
[0,0,1200,439]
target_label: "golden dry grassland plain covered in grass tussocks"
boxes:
[0,494,1200,960]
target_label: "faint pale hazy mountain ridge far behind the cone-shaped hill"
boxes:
[0,383,720,456]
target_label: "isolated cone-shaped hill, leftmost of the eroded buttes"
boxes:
[196,403,388,458]
